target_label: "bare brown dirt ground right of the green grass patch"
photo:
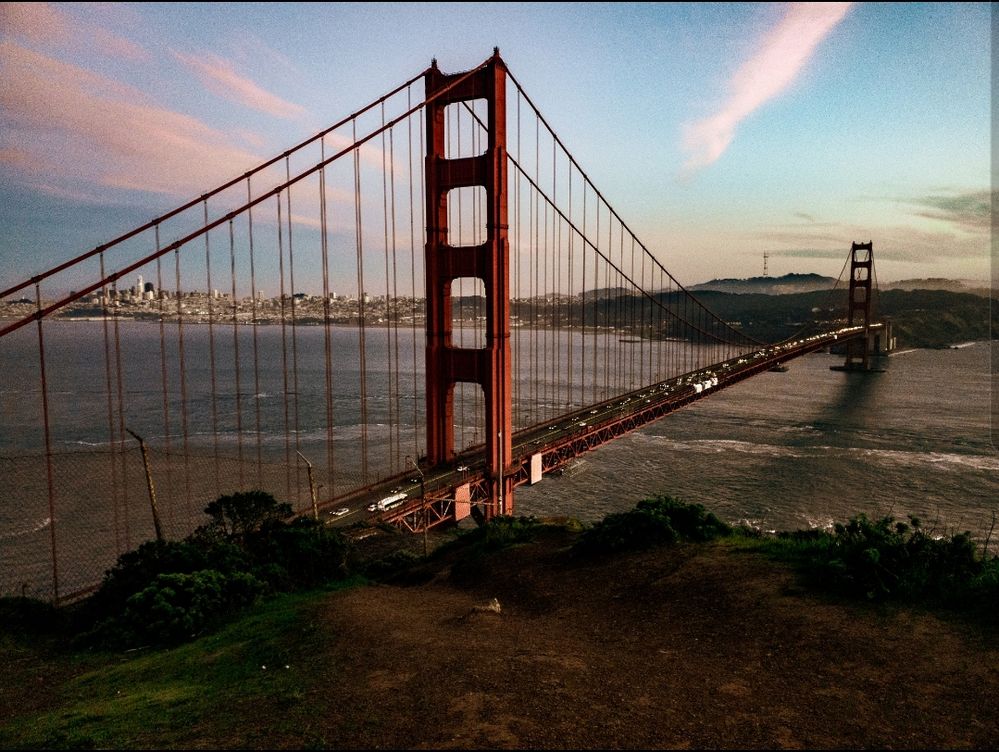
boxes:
[308,538,999,749]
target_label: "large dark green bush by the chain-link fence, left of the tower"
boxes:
[75,491,349,647]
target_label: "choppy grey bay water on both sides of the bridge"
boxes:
[0,322,999,592]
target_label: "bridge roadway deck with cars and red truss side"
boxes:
[320,324,868,532]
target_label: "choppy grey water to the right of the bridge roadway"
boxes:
[517,343,999,533]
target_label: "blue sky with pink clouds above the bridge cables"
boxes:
[0,3,991,298]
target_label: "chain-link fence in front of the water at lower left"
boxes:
[0,442,370,603]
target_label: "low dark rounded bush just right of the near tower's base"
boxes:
[573,496,731,555]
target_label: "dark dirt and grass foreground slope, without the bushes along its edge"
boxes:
[0,529,999,749]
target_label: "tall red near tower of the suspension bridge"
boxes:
[425,50,513,519]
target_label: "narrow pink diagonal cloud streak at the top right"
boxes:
[683,3,852,175]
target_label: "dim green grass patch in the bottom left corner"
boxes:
[0,590,364,749]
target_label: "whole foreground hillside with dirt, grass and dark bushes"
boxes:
[0,497,999,749]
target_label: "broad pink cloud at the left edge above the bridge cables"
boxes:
[0,41,260,196]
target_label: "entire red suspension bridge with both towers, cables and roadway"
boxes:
[0,50,891,601]
